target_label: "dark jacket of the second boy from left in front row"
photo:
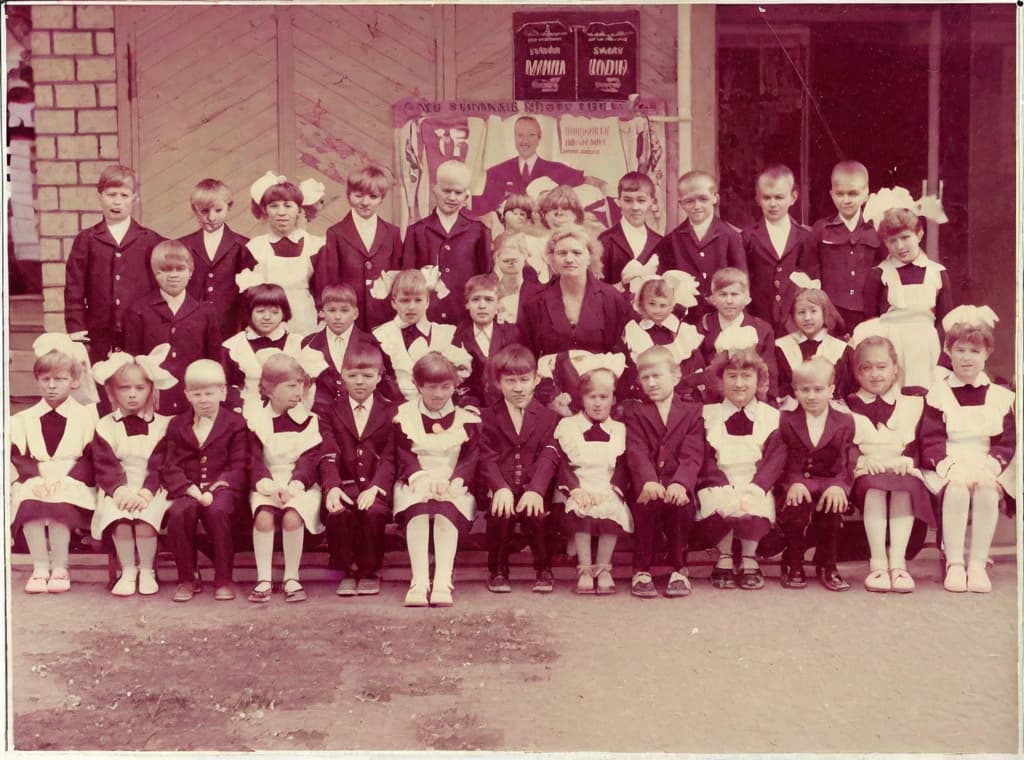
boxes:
[319,393,397,504]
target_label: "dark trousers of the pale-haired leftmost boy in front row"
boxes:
[165,488,239,586]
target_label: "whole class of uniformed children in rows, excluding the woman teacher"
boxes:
[11,154,1016,606]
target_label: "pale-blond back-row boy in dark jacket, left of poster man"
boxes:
[402,161,494,325]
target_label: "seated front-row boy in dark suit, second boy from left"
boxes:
[321,342,395,596]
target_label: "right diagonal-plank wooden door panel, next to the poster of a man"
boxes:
[285,5,439,230]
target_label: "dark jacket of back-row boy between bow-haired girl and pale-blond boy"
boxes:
[313,211,402,333]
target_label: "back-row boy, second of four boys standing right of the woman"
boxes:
[644,171,746,325]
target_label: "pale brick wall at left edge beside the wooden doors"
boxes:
[32,4,119,330]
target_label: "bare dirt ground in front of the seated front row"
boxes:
[8,554,1020,753]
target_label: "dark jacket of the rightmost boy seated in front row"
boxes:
[778,407,858,496]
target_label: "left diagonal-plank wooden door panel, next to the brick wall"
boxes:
[115,5,279,237]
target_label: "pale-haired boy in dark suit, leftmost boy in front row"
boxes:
[161,358,249,601]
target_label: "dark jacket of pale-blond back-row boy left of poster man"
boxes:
[402,211,495,325]
